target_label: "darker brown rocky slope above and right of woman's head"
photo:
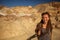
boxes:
[34,2,60,25]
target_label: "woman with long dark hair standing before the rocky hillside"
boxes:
[35,12,52,40]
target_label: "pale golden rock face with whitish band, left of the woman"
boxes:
[0,6,40,40]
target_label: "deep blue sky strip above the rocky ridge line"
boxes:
[0,0,60,7]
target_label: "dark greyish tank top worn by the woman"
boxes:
[38,28,51,40]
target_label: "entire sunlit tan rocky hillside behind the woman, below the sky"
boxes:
[0,3,60,40]
